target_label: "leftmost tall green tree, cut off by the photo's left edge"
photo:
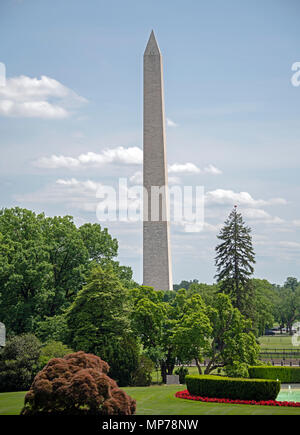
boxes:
[0,208,52,334]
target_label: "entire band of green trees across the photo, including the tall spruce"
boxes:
[0,208,300,392]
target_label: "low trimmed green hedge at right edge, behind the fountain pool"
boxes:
[248,366,300,384]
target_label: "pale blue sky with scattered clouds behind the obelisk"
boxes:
[0,0,300,283]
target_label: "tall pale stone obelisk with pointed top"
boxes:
[143,31,173,290]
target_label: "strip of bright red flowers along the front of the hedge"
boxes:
[175,390,300,408]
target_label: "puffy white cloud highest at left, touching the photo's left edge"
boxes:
[0,75,86,119]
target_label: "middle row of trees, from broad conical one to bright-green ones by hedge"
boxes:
[29,266,259,385]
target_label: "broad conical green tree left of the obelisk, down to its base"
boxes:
[66,265,139,386]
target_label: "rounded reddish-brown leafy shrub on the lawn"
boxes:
[21,352,136,415]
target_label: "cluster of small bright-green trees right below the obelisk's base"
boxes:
[131,287,259,382]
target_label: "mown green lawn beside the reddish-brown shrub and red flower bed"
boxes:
[0,386,300,415]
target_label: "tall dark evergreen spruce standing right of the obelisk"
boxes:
[215,206,255,317]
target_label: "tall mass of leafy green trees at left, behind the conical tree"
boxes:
[0,207,123,334]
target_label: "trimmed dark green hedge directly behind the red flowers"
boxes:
[185,375,280,402]
